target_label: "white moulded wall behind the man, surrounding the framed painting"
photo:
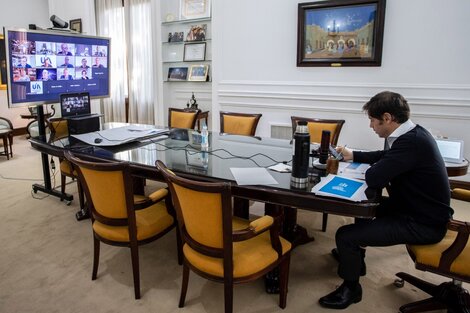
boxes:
[211,0,470,158]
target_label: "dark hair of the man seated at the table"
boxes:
[362,91,410,124]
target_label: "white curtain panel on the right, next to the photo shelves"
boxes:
[124,0,156,124]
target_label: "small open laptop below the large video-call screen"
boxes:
[60,92,99,119]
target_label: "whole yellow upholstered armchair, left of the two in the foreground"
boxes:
[65,151,180,299]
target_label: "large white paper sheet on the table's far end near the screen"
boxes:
[71,125,168,146]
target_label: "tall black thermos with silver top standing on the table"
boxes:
[291,121,310,188]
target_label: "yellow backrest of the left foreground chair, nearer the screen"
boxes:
[65,151,135,225]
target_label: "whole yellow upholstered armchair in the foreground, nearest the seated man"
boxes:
[156,161,291,313]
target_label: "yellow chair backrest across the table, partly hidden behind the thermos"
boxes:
[291,116,345,145]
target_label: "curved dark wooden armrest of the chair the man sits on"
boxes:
[439,220,470,271]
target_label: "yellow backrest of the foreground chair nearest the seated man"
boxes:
[156,161,232,258]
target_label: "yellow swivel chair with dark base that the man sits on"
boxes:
[395,189,470,312]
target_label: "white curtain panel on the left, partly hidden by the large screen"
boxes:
[96,0,127,122]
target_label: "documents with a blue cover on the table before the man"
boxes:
[312,175,367,202]
